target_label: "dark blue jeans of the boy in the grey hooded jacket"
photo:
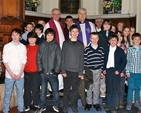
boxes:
[39,74,60,109]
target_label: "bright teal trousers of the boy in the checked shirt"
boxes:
[127,73,141,101]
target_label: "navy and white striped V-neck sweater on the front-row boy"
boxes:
[84,44,104,70]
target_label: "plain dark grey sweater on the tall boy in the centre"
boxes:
[61,39,84,75]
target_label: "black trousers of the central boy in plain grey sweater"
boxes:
[63,71,80,109]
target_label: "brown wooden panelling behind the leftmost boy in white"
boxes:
[0,0,25,76]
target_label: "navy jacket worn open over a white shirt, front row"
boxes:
[104,46,127,73]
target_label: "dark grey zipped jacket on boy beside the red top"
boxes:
[37,40,61,73]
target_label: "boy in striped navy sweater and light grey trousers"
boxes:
[84,32,104,111]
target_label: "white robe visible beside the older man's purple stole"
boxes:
[80,22,95,46]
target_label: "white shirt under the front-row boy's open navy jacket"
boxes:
[106,46,117,68]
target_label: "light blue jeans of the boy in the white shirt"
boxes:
[3,77,24,113]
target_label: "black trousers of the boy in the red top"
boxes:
[24,72,41,106]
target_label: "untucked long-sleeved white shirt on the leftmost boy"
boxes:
[3,42,27,78]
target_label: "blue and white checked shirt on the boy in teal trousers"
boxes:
[126,46,141,73]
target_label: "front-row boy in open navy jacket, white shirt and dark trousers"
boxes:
[103,34,126,113]
